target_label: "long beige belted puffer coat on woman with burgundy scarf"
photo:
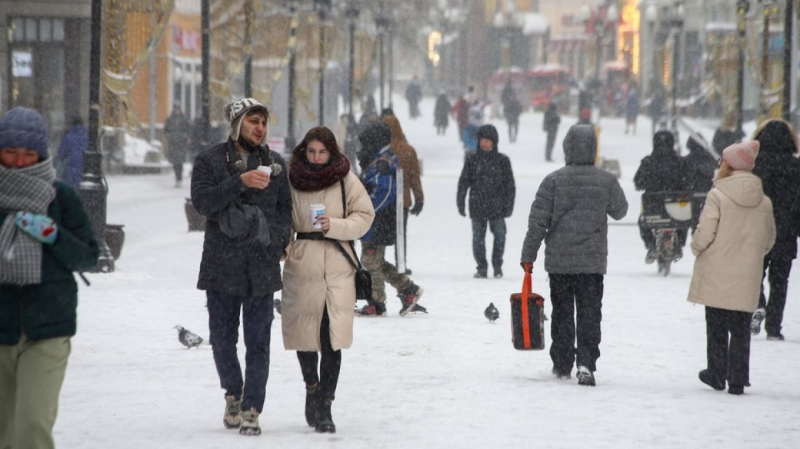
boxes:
[281,173,375,352]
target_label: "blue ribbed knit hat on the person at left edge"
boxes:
[0,106,49,159]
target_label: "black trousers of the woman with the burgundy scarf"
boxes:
[297,307,342,399]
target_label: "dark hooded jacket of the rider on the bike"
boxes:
[633,131,686,192]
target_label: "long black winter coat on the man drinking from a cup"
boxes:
[191,138,292,297]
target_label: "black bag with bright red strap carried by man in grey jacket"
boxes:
[511,270,544,350]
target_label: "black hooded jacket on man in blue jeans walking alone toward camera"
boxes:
[456,125,517,220]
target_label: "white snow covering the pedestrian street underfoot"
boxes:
[55,97,800,449]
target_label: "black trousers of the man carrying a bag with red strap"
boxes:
[550,273,603,372]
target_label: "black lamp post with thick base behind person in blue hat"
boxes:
[78,0,114,273]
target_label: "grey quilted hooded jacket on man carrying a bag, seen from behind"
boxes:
[522,125,628,274]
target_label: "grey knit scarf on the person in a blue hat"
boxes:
[0,157,56,285]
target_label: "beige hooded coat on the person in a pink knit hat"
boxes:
[688,170,775,312]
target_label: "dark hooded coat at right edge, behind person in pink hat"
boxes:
[753,121,800,260]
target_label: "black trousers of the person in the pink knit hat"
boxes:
[706,306,752,385]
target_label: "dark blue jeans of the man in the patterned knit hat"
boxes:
[206,290,274,413]
